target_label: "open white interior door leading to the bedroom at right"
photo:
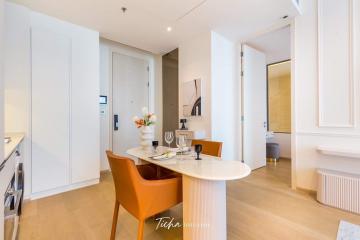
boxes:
[242,45,267,169]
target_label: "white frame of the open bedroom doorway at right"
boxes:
[237,19,297,189]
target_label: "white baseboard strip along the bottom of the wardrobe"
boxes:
[25,178,100,200]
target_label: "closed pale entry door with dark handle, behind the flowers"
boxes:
[112,53,149,156]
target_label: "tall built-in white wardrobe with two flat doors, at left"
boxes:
[7,4,100,198]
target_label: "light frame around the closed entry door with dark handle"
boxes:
[108,46,155,150]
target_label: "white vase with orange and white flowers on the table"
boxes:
[133,107,156,150]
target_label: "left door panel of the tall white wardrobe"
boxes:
[31,28,71,193]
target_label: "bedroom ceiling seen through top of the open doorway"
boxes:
[247,26,291,64]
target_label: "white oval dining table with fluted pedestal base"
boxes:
[127,147,251,240]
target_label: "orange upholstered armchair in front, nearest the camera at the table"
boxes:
[106,151,182,240]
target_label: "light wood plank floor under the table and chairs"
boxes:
[19,159,360,240]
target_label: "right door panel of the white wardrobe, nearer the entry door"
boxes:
[71,28,100,183]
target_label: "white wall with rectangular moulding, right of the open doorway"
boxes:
[293,0,360,190]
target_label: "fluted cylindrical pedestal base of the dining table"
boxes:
[183,175,226,240]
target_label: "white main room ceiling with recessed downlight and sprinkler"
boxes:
[11,0,297,53]
